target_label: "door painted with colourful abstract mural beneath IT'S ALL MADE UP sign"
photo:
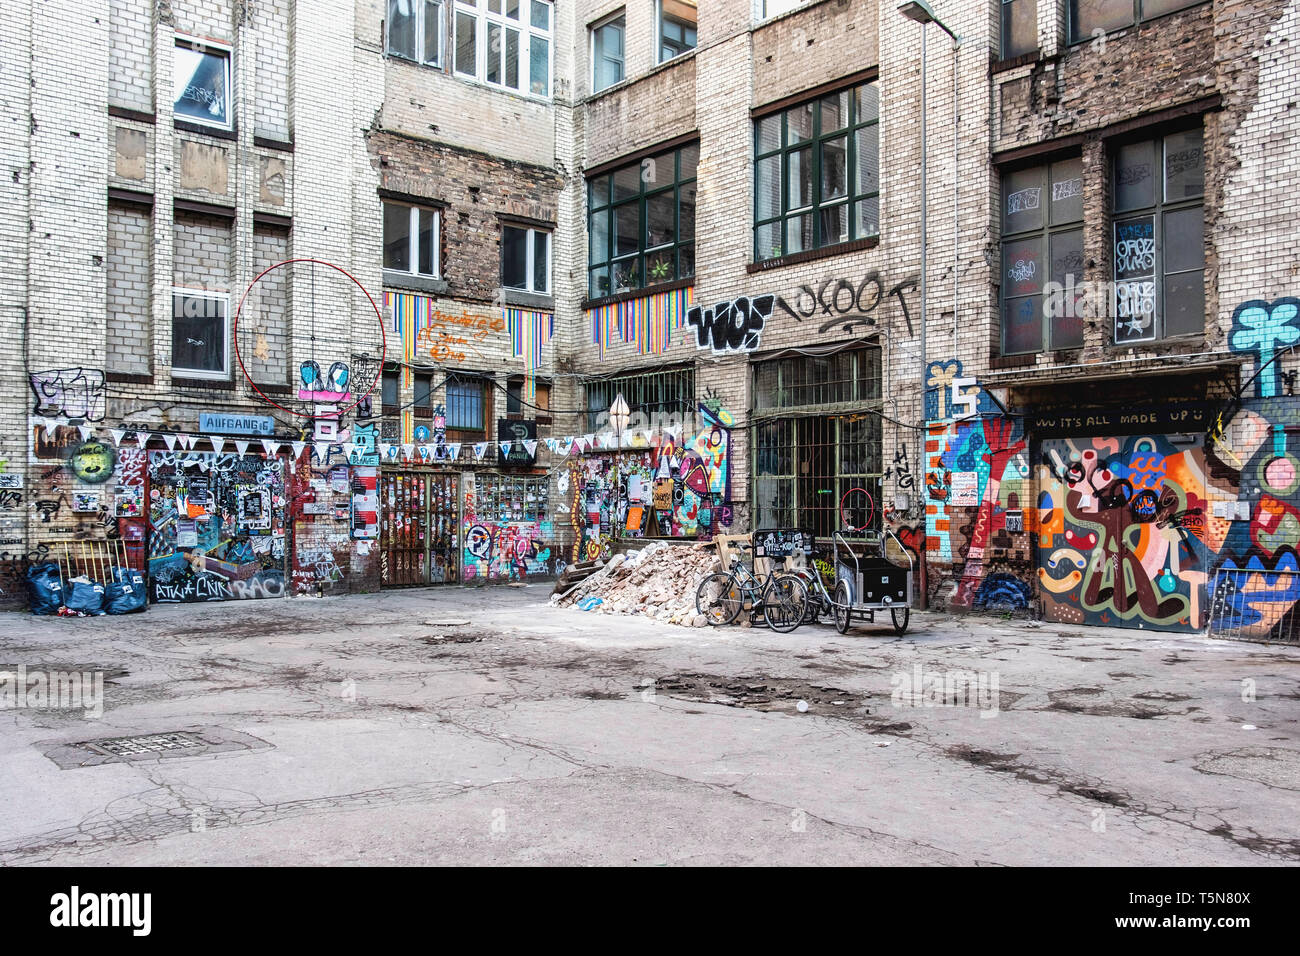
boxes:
[1039,436,1208,631]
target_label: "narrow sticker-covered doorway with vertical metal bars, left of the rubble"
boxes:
[380,472,460,588]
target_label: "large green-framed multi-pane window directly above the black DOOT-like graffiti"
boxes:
[754,83,880,261]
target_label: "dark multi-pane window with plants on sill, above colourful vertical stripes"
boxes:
[588,143,699,299]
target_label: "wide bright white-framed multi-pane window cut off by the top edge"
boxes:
[452,0,554,98]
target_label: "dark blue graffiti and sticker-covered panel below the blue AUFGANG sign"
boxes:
[148,451,286,604]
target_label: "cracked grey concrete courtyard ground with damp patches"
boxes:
[0,587,1300,865]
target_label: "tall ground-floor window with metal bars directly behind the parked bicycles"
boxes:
[753,346,883,537]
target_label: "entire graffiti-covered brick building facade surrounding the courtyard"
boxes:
[0,0,1300,642]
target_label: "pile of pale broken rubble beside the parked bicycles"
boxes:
[551,541,722,627]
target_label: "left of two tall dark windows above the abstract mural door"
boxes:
[1002,157,1086,355]
